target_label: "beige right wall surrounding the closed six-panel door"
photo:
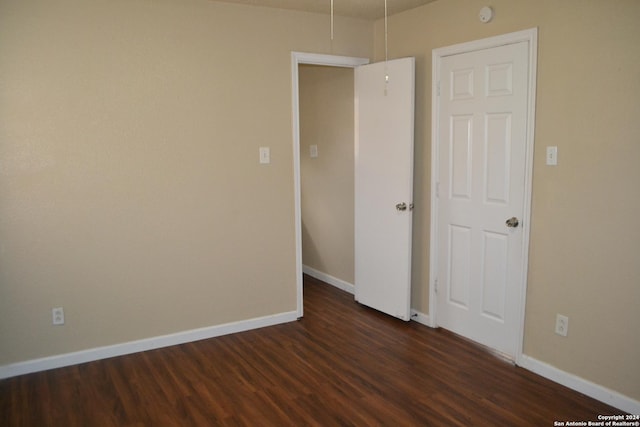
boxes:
[376,0,640,399]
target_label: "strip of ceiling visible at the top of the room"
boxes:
[212,0,435,19]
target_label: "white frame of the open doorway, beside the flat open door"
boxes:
[291,52,369,318]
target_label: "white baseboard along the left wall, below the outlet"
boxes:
[0,311,298,379]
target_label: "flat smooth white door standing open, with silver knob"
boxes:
[355,58,415,320]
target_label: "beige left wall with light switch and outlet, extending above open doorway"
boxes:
[0,0,373,366]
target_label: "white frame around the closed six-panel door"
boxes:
[429,28,538,364]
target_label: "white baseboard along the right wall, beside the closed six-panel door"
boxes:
[518,354,640,414]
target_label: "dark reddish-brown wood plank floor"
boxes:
[0,277,620,427]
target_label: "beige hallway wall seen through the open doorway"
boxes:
[299,65,354,284]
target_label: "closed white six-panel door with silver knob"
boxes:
[436,42,529,357]
